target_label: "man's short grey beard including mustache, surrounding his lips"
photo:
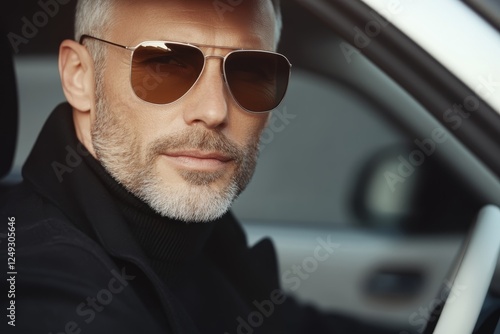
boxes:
[91,82,259,222]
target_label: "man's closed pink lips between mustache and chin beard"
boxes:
[163,151,233,171]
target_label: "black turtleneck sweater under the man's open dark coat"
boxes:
[83,145,273,333]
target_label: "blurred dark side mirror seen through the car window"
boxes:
[351,144,482,233]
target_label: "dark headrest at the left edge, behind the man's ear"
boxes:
[0,26,18,178]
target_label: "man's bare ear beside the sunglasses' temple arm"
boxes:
[59,40,95,112]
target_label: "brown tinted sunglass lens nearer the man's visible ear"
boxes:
[131,43,205,104]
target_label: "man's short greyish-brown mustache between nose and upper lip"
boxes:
[148,127,247,163]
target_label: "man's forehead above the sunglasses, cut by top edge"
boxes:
[109,0,276,50]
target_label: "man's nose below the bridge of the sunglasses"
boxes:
[184,58,230,129]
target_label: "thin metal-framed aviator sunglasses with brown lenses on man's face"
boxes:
[80,35,291,113]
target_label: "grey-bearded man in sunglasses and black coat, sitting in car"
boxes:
[2,0,396,334]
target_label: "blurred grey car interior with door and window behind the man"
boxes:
[0,0,500,333]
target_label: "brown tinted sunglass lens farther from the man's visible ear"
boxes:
[224,51,290,112]
